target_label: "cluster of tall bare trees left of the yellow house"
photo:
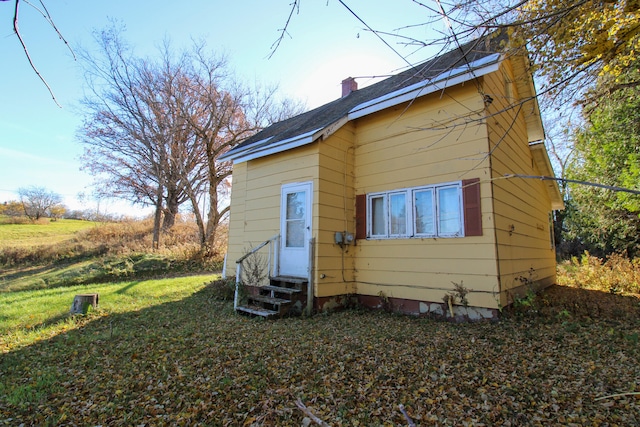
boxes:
[80,28,301,249]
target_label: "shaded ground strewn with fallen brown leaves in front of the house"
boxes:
[0,287,640,426]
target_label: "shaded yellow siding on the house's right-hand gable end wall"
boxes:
[484,62,556,305]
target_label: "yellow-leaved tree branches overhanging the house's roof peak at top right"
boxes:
[441,0,640,103]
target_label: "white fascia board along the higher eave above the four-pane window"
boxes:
[349,53,501,120]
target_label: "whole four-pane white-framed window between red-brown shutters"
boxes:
[367,182,464,239]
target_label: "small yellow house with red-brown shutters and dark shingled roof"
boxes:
[222,33,564,319]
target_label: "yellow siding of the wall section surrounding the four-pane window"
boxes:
[354,84,499,308]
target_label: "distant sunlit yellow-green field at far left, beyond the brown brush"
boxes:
[0,219,99,248]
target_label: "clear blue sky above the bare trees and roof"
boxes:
[0,0,442,213]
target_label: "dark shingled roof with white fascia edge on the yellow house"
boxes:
[220,31,506,162]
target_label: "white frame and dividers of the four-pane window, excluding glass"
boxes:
[367,181,464,240]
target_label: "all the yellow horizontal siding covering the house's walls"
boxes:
[227,58,555,308]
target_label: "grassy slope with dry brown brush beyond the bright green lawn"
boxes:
[0,220,222,293]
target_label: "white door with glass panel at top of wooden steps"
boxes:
[280,182,312,277]
